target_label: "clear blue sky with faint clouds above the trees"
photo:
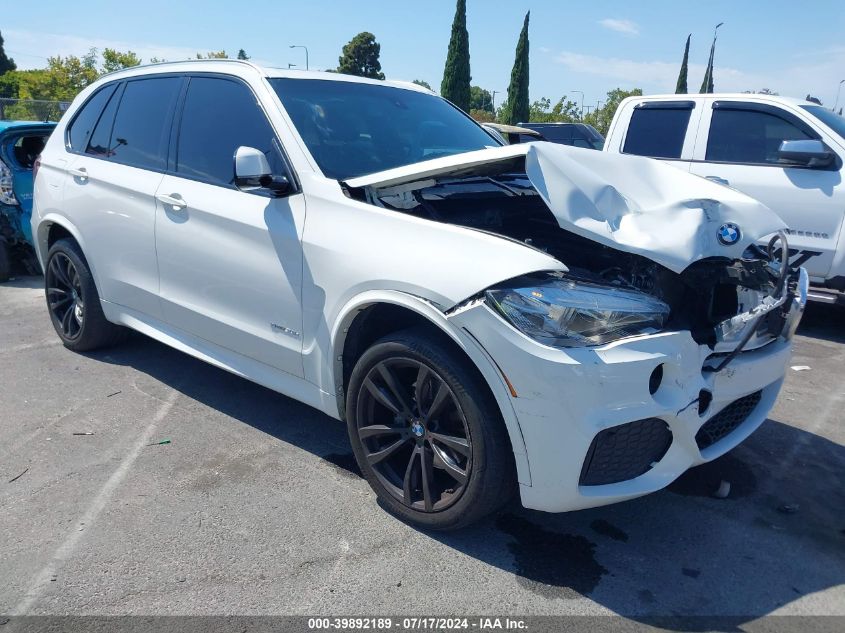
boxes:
[0,0,845,106]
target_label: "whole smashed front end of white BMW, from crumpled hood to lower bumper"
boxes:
[344,143,807,512]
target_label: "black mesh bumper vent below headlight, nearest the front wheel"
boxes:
[579,418,672,486]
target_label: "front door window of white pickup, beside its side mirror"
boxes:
[705,107,818,164]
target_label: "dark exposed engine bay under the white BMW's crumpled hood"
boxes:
[349,170,797,351]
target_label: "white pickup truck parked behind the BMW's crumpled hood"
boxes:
[604,94,845,305]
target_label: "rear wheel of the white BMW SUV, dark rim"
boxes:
[44,238,126,352]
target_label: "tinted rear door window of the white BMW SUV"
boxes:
[106,77,182,170]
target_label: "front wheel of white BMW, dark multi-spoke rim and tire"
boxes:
[346,329,516,530]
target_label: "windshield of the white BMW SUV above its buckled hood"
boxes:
[270,78,496,180]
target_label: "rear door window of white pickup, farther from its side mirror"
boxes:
[622,101,694,158]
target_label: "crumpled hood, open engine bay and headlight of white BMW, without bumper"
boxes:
[346,143,807,360]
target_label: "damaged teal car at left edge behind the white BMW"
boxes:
[0,121,56,282]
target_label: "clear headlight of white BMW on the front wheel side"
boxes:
[485,276,669,347]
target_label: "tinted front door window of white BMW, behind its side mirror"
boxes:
[176,77,286,186]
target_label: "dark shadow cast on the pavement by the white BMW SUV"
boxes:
[89,335,845,631]
